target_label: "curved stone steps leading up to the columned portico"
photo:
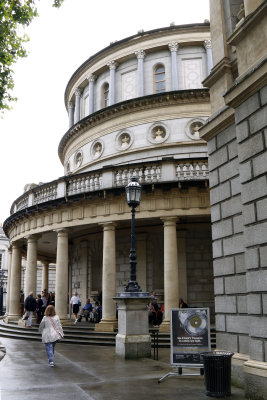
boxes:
[0,320,216,349]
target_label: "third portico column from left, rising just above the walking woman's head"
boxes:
[56,229,68,324]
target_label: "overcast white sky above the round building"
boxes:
[0,0,209,223]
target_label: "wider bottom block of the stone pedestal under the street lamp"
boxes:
[116,333,151,359]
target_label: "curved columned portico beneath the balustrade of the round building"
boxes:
[3,177,214,331]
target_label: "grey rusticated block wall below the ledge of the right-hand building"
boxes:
[208,87,267,361]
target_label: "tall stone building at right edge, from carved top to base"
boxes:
[200,0,267,399]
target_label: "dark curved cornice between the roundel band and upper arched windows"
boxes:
[58,88,209,164]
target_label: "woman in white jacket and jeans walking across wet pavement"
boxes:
[39,305,64,367]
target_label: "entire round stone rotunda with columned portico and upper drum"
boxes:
[4,23,214,331]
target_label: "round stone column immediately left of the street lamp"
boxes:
[95,222,117,332]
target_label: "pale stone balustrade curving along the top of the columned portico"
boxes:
[10,160,209,214]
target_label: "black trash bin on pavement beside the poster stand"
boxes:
[201,351,234,397]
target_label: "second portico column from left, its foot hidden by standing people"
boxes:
[25,235,40,297]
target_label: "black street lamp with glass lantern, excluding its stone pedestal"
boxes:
[125,176,142,292]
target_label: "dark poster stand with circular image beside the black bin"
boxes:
[158,308,211,383]
